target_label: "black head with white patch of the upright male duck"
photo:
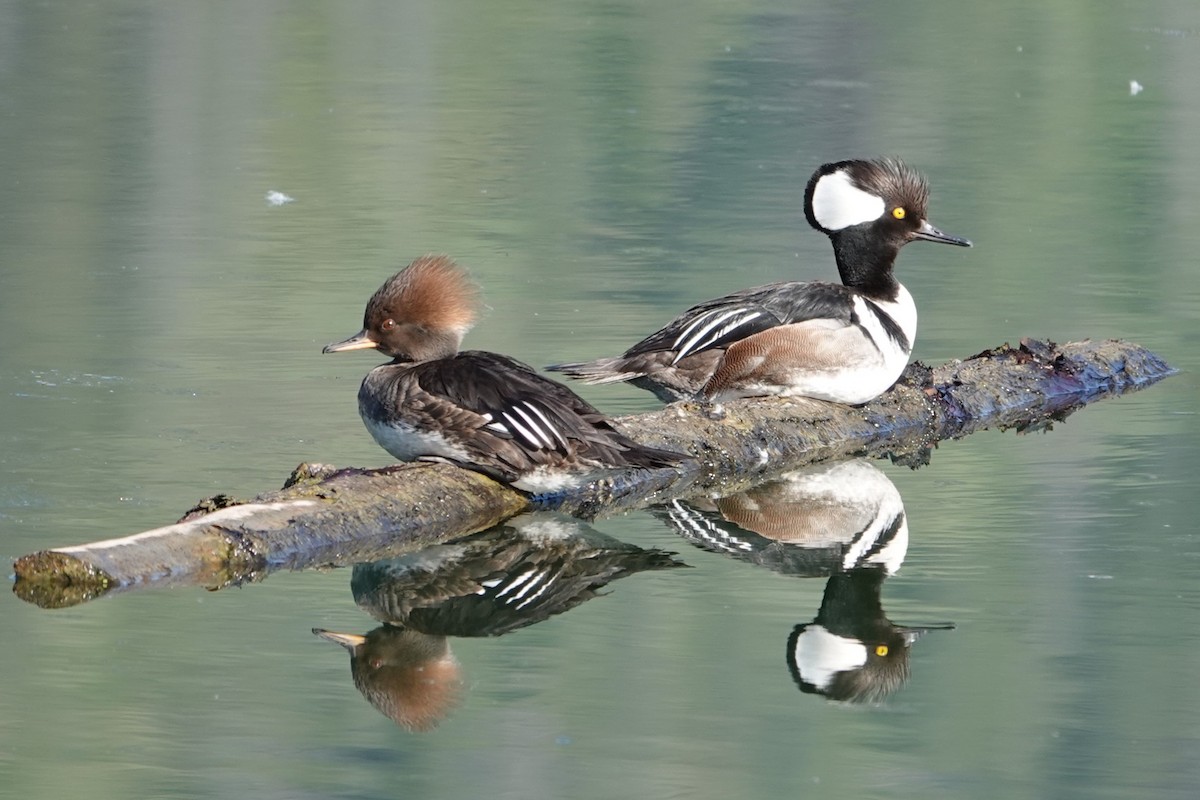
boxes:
[804,158,971,291]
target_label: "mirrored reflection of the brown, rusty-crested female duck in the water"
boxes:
[313,515,686,730]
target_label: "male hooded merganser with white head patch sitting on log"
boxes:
[547,158,971,405]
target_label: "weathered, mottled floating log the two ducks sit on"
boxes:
[14,341,1172,606]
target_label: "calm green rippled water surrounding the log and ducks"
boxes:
[0,0,1200,799]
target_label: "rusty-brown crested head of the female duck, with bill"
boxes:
[322,255,479,361]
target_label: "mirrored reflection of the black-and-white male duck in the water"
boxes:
[665,461,948,702]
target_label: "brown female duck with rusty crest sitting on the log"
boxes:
[324,255,684,492]
